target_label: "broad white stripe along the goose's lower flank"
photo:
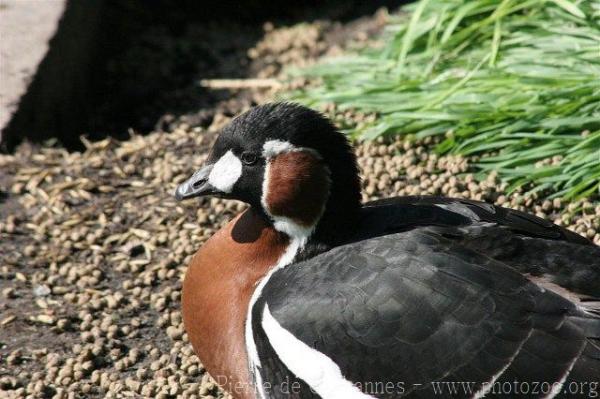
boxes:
[262,304,373,399]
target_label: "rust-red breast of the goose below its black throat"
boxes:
[182,209,288,399]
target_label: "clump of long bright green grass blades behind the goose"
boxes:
[290,0,600,199]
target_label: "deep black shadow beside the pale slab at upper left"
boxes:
[2,0,405,151]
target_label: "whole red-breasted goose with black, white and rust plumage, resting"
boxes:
[176,103,600,399]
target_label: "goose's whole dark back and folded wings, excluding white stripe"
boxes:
[253,197,600,398]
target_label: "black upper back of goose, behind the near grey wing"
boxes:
[356,197,600,297]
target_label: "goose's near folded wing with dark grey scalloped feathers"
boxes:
[253,228,600,397]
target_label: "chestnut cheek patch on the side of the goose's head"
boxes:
[263,149,330,227]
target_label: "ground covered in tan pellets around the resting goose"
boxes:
[0,6,600,398]
